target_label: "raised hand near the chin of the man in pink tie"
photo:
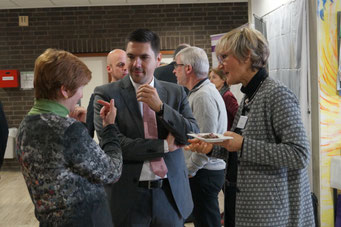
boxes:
[136,84,162,112]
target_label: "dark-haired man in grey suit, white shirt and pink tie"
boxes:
[95,29,198,227]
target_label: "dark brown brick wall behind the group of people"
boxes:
[0,3,248,127]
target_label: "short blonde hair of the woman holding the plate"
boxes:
[215,27,270,69]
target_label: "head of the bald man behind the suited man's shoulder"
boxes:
[107,49,128,82]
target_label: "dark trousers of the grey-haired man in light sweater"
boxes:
[189,169,225,227]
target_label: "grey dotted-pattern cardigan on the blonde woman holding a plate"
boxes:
[212,77,314,227]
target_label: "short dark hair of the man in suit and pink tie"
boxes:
[127,28,160,56]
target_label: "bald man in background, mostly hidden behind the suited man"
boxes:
[86,49,128,138]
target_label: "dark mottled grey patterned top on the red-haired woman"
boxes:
[16,113,122,226]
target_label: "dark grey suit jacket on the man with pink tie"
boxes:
[95,76,199,225]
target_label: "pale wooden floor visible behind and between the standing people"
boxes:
[0,171,223,227]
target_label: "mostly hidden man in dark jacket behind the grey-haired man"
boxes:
[154,43,190,84]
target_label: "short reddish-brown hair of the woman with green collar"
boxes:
[34,49,91,100]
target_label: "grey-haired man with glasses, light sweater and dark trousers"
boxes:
[174,47,227,227]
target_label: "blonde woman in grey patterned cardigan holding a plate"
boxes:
[187,27,314,227]
